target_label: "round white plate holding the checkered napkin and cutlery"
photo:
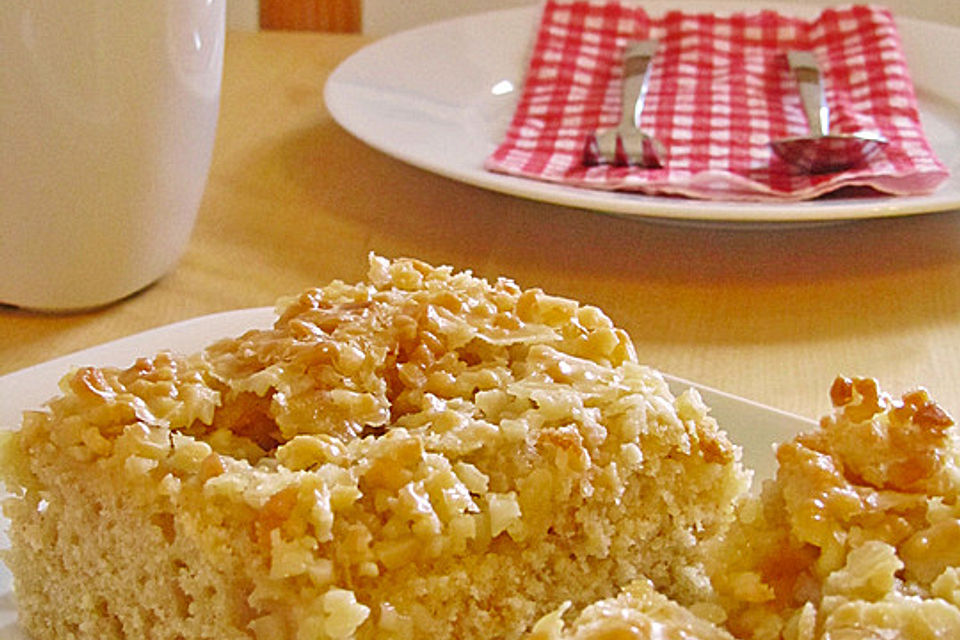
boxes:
[324,0,960,223]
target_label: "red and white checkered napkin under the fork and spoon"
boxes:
[486,0,947,200]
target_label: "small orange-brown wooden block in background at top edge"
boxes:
[260,0,361,33]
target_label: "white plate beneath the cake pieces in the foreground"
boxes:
[0,307,816,640]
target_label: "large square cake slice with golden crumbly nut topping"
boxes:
[2,257,748,640]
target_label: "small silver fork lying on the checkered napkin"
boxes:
[583,40,666,168]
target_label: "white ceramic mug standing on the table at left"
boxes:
[0,0,225,310]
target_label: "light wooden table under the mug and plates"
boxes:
[0,28,960,417]
